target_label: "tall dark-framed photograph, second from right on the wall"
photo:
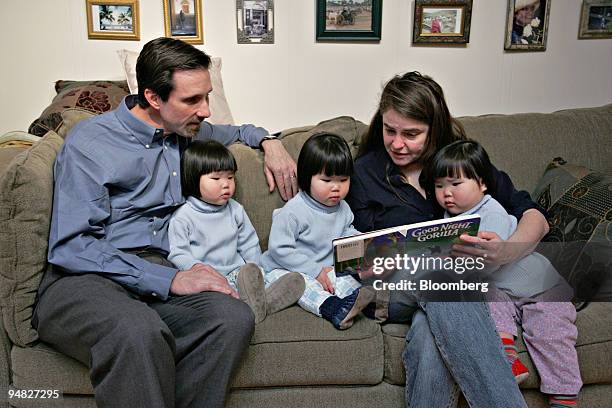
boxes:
[504,0,551,51]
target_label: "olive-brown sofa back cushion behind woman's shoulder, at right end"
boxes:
[459,104,612,191]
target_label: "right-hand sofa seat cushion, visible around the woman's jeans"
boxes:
[382,302,612,389]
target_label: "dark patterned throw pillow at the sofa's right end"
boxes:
[533,158,612,301]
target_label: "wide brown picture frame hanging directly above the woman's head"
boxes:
[412,0,472,45]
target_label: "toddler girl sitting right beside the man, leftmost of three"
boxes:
[168,140,304,323]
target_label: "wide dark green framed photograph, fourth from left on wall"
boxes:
[317,0,382,41]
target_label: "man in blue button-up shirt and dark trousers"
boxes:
[33,38,294,408]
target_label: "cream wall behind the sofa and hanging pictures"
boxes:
[0,0,612,134]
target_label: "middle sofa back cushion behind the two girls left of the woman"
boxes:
[230,116,367,250]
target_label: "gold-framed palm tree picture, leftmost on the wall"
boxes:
[85,0,140,40]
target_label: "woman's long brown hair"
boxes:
[357,71,466,164]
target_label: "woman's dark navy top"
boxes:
[346,149,543,232]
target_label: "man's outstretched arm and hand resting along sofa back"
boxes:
[196,122,299,201]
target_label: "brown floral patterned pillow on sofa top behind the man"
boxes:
[28,80,130,136]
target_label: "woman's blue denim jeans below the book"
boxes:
[389,296,527,408]
